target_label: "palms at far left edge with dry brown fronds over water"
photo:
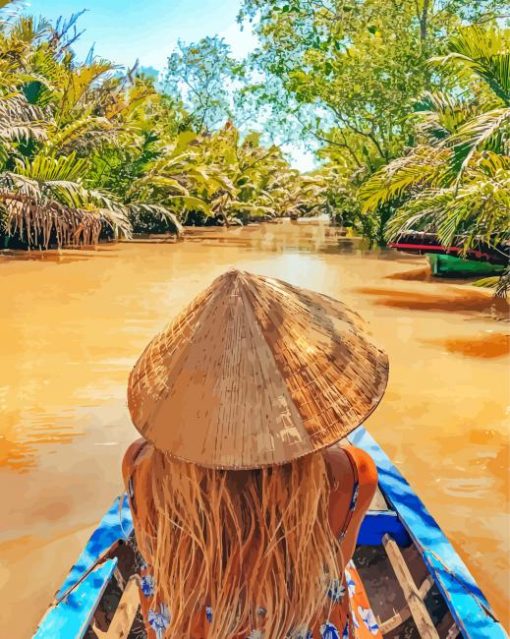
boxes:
[0,17,130,248]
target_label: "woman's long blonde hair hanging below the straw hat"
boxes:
[135,450,343,639]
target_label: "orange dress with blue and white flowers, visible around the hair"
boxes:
[128,449,383,639]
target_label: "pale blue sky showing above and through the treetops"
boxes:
[25,0,315,171]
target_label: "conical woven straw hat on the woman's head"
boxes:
[128,271,388,469]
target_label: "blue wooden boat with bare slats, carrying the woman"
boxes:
[34,427,508,639]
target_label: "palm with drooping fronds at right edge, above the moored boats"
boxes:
[360,26,510,292]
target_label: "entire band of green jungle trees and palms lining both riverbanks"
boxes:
[0,0,510,290]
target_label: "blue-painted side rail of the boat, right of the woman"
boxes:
[349,427,508,639]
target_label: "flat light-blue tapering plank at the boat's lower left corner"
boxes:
[33,559,117,639]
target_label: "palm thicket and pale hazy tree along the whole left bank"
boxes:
[0,14,326,247]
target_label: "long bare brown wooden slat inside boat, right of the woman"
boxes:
[383,535,439,639]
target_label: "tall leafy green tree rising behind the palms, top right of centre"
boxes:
[240,0,504,172]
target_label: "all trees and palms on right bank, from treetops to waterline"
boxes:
[241,0,510,294]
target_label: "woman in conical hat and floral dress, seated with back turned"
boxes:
[123,271,388,639]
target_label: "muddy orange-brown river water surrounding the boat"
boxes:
[0,223,510,639]
